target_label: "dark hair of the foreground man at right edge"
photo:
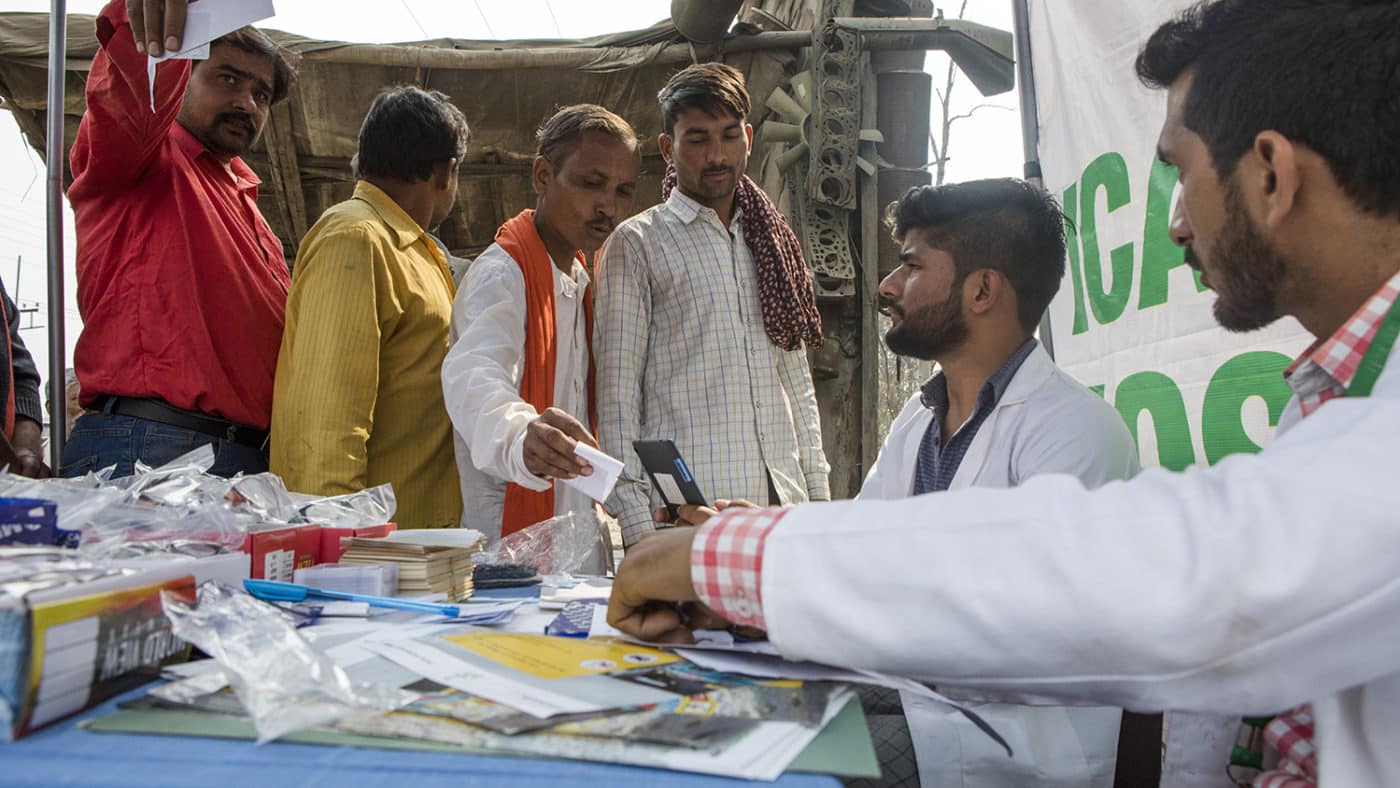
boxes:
[1137,0,1400,216]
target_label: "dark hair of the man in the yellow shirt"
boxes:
[356,85,470,181]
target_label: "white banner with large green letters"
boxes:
[1030,0,1312,469]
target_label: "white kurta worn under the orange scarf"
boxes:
[442,244,603,572]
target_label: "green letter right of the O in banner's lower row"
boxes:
[1201,350,1292,465]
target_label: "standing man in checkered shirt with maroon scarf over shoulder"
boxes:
[594,63,832,547]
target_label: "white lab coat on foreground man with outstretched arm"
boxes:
[762,345,1400,787]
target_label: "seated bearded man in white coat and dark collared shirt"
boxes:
[858,178,1138,788]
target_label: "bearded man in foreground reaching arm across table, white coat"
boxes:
[608,0,1400,787]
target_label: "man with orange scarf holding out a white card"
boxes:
[442,104,640,572]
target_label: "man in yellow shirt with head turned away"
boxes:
[272,87,468,528]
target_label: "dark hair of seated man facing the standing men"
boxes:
[885,178,1064,333]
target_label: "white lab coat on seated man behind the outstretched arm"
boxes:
[858,346,1138,788]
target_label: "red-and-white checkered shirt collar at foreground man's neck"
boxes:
[1284,273,1400,416]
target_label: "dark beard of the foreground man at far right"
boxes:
[1204,179,1288,332]
